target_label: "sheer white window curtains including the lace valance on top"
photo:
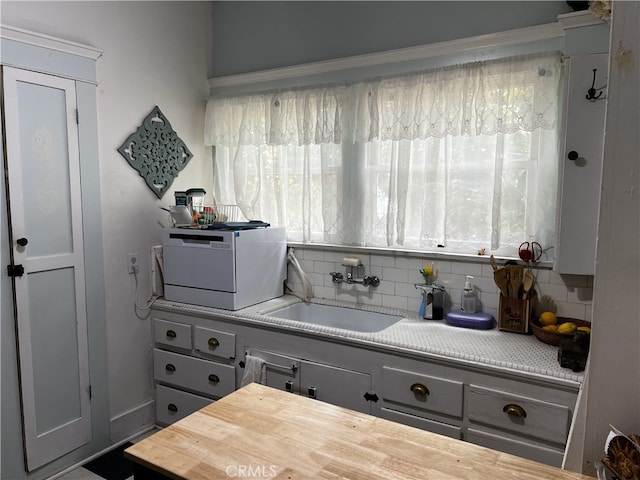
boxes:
[205,53,561,253]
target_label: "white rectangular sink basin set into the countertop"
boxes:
[269,303,403,332]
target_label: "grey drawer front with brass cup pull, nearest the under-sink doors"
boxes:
[382,367,464,418]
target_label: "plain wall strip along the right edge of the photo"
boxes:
[584,2,640,471]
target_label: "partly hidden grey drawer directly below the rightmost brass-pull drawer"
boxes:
[466,428,564,467]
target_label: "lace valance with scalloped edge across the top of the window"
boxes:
[205,53,561,147]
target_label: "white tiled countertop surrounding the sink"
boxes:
[153,295,584,387]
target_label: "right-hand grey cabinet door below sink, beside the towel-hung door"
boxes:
[300,361,371,413]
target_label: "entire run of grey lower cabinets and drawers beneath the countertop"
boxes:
[152,309,578,466]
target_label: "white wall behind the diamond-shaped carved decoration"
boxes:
[2,1,213,441]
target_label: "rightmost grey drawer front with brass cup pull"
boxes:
[469,385,571,445]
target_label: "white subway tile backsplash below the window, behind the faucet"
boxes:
[287,246,593,321]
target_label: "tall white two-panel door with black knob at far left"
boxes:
[3,67,91,470]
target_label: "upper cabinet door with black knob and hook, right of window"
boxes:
[555,53,609,275]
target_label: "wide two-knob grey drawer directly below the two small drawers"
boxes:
[153,349,236,397]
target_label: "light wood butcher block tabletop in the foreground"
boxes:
[124,383,593,480]
